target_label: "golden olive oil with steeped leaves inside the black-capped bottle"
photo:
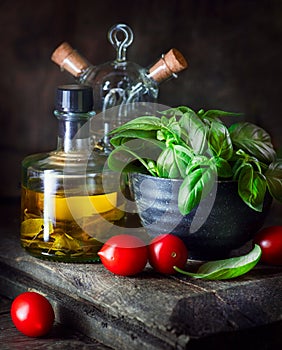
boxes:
[21,188,124,262]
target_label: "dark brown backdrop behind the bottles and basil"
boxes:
[0,0,282,198]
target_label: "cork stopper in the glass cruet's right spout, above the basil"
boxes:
[149,48,188,82]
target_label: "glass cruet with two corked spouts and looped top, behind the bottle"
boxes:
[51,24,187,154]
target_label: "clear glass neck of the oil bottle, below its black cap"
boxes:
[54,111,95,153]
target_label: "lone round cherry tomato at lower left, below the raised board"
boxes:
[11,292,55,337]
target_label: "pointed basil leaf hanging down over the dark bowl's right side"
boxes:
[238,163,266,211]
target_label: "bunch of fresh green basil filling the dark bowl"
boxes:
[108,106,282,215]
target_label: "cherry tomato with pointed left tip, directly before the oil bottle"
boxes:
[98,234,148,276]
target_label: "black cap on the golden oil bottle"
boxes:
[55,84,93,113]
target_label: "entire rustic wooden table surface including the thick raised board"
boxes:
[0,201,282,350]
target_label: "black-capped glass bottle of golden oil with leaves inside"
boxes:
[21,85,124,262]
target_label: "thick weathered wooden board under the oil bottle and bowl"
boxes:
[0,227,282,349]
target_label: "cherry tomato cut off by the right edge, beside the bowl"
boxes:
[254,226,282,265]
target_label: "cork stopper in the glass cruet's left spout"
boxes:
[51,42,89,78]
